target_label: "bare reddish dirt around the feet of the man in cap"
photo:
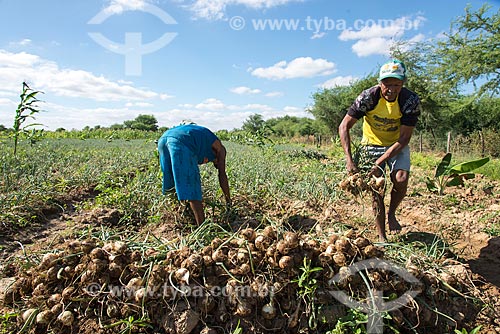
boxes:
[328,176,500,334]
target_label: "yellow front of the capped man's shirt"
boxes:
[361,97,402,146]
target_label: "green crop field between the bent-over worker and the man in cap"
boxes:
[202,143,342,211]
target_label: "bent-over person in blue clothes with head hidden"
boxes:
[158,124,231,224]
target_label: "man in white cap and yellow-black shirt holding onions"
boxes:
[339,59,420,242]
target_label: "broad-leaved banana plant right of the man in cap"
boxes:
[426,153,490,195]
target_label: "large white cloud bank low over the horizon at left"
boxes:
[0,50,307,130]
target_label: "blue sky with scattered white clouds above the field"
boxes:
[0,0,500,131]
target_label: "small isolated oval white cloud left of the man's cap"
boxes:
[251,57,336,80]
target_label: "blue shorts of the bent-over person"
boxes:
[158,137,202,201]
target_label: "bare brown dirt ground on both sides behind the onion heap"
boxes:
[0,171,500,334]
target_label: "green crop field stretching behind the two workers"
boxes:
[0,138,500,234]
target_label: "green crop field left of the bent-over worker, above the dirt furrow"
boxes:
[0,139,157,226]
